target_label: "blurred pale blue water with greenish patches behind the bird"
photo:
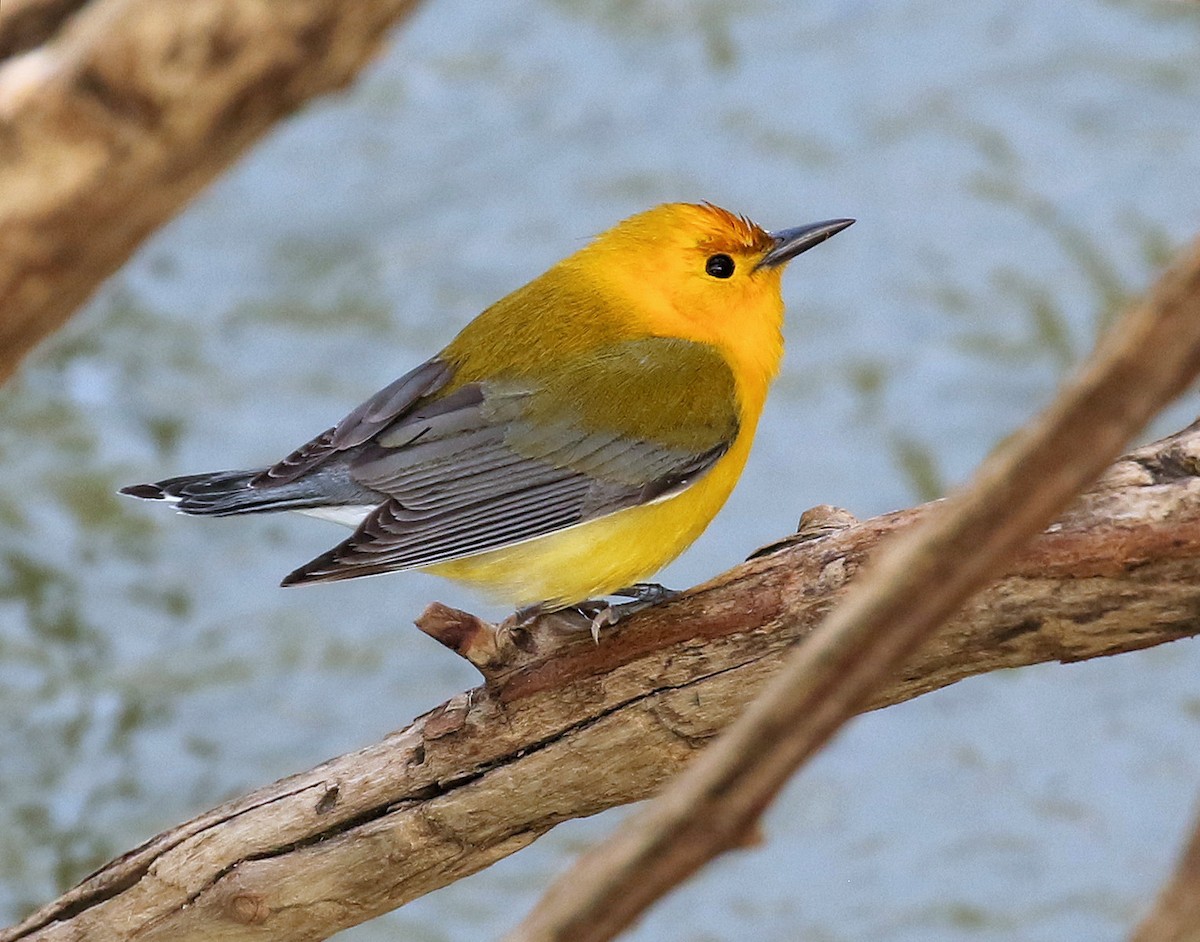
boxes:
[0,0,1200,942]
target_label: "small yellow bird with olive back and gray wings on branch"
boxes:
[121,203,854,635]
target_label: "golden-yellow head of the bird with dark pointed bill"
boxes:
[563,203,853,396]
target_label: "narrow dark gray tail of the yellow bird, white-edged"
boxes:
[121,469,329,517]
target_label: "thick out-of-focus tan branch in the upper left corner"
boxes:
[0,0,427,382]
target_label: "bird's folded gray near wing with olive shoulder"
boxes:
[284,338,737,584]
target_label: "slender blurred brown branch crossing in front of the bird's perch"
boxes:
[509,229,1200,942]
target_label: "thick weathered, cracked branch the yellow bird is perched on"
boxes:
[7,426,1200,942]
